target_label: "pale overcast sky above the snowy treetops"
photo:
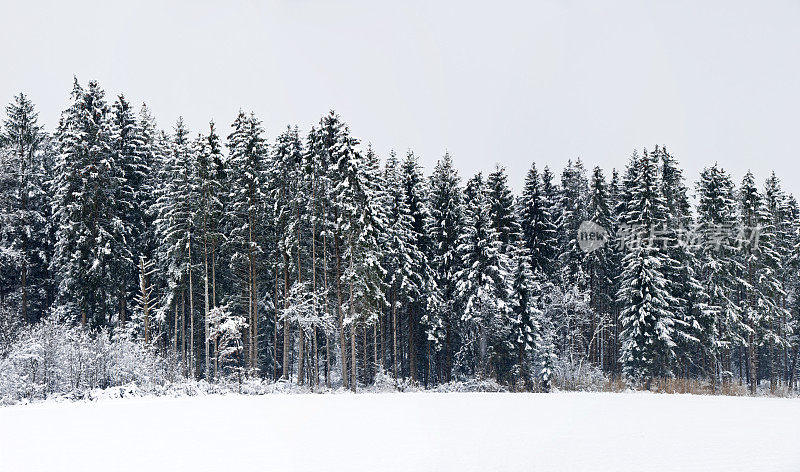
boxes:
[0,0,800,194]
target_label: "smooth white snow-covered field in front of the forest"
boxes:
[0,393,800,472]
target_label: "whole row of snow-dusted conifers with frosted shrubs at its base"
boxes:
[0,80,800,400]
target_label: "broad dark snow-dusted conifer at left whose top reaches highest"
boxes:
[53,80,120,327]
